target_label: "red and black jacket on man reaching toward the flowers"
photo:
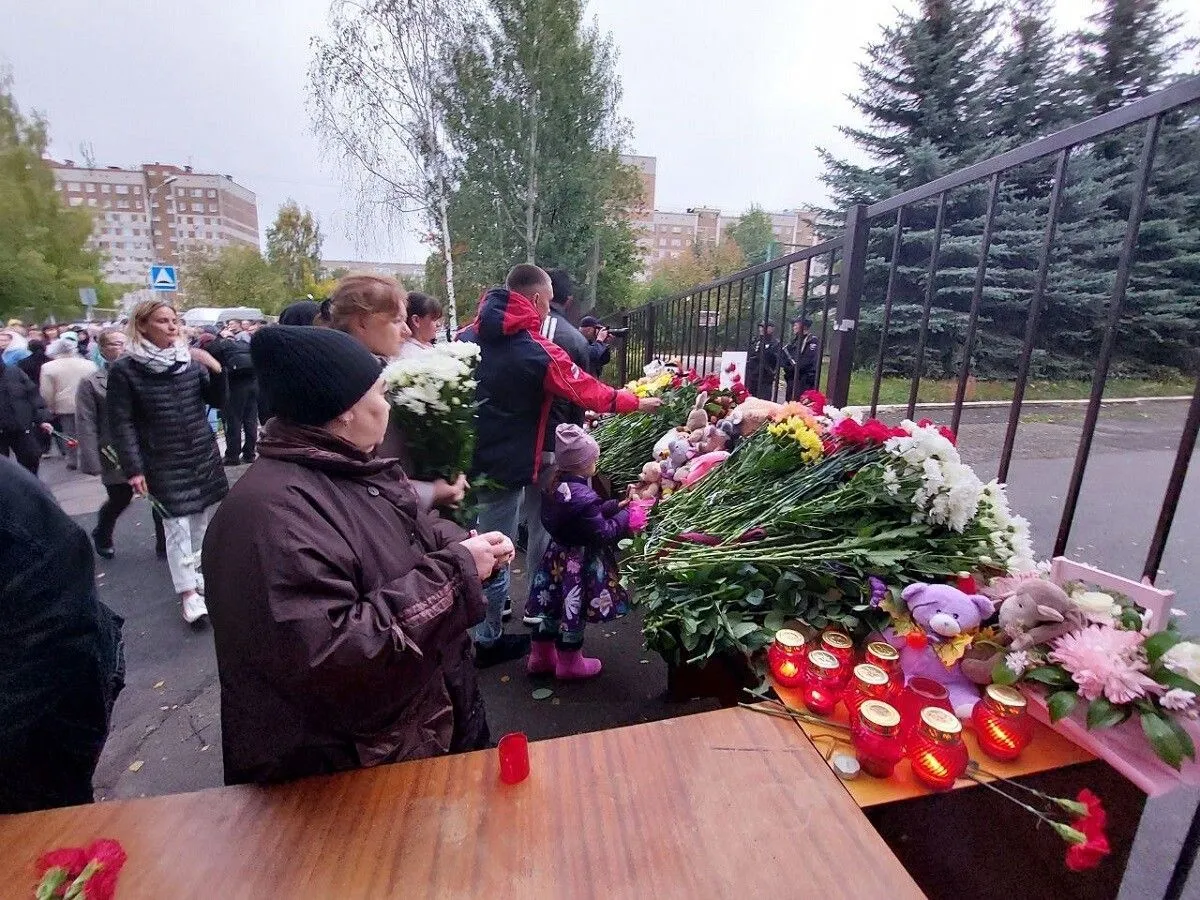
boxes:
[460,288,638,488]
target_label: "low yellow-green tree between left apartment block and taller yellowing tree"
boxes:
[180,246,294,314]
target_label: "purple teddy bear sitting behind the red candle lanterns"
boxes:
[883,583,995,718]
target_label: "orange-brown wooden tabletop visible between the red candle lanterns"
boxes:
[775,685,1096,806]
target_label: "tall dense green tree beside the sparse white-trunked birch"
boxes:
[445,0,629,296]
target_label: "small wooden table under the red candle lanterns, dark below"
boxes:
[775,686,1146,900]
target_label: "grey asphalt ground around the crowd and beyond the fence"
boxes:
[35,403,1200,899]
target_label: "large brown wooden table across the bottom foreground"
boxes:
[0,709,922,900]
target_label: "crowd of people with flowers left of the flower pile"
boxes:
[0,265,659,811]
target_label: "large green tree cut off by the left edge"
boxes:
[0,74,102,319]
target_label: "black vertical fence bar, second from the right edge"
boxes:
[1054,116,1163,556]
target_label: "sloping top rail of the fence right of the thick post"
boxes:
[866,76,1200,218]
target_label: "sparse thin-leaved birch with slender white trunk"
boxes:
[308,0,473,329]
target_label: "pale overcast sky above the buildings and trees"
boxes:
[0,0,1200,262]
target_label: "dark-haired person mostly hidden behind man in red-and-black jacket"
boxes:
[521,269,595,600]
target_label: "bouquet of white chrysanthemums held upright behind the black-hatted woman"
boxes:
[383,342,479,482]
